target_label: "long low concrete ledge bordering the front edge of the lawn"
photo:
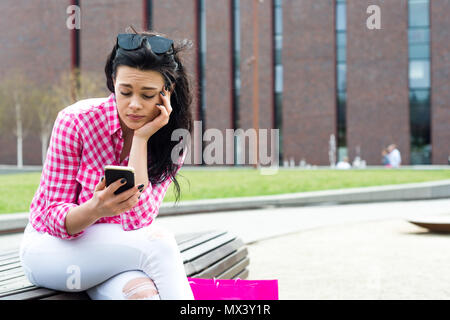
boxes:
[0,180,450,233]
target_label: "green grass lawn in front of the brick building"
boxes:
[0,168,450,213]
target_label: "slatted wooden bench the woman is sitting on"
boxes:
[0,231,250,300]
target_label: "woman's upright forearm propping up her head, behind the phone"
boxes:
[128,136,148,188]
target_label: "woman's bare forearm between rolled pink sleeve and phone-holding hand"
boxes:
[65,200,100,235]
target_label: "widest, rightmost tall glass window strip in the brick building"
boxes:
[408,0,431,164]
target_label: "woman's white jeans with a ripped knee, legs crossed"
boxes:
[20,222,194,300]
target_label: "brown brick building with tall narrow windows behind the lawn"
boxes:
[0,0,450,165]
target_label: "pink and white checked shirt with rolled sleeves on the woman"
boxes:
[30,93,186,239]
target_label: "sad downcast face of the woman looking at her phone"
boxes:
[114,65,164,135]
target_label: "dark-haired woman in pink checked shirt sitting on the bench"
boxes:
[20,29,193,300]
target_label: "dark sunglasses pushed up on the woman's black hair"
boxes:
[117,33,173,54]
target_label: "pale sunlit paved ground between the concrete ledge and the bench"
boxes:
[0,200,450,299]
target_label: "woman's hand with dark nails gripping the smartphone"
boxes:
[91,178,144,218]
